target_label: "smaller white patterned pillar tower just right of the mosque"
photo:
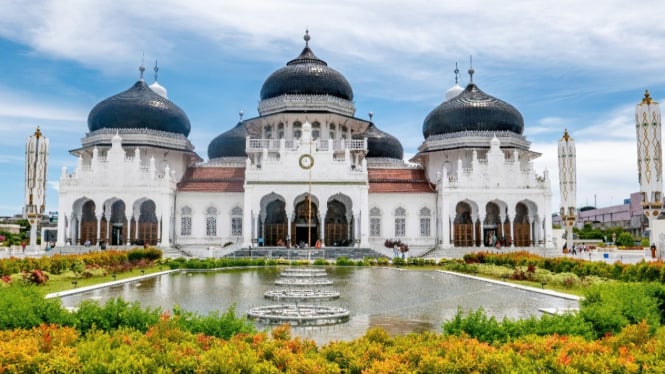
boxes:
[559,130,577,249]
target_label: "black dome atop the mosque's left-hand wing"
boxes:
[88,80,191,136]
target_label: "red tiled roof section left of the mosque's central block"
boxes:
[178,167,245,192]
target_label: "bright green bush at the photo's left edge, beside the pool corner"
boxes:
[0,285,72,330]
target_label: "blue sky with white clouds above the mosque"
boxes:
[0,0,665,216]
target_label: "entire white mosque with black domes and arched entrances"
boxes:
[58,33,552,255]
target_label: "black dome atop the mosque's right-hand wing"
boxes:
[423,83,524,138]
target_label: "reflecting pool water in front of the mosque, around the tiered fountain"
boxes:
[62,266,578,344]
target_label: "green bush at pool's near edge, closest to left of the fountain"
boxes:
[173,305,256,339]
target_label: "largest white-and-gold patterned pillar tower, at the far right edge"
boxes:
[635,90,663,248]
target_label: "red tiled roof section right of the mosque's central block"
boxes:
[367,169,434,193]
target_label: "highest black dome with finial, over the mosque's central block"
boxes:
[261,34,353,100]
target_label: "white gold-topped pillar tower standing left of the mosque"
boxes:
[23,127,48,250]
